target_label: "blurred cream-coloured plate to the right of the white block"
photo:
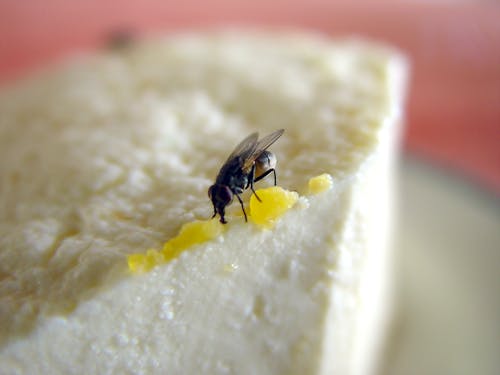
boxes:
[382,158,500,375]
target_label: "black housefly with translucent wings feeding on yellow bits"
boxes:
[208,129,285,224]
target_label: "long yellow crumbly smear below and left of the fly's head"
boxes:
[127,219,224,273]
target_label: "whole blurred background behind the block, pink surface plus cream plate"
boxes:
[0,0,500,374]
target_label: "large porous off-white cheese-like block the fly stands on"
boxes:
[0,32,404,374]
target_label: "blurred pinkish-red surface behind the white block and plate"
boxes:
[0,0,500,194]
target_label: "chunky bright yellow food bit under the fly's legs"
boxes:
[250,186,299,229]
